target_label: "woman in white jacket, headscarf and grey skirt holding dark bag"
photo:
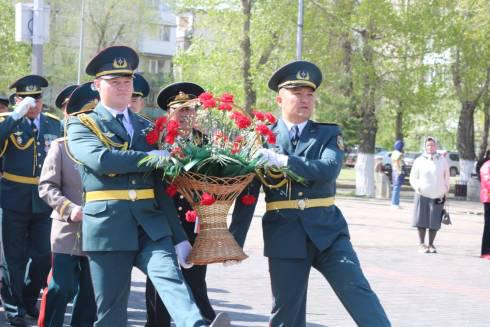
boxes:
[410,137,449,253]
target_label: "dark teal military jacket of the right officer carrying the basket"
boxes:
[230,120,349,258]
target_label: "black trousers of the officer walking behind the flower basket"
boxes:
[145,266,216,327]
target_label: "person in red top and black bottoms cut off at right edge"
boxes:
[477,150,490,259]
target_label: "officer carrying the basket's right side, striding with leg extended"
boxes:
[230,61,390,327]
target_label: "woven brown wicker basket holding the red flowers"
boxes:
[174,172,255,265]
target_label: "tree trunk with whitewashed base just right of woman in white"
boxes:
[457,101,476,182]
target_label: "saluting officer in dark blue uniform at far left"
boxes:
[0,75,61,326]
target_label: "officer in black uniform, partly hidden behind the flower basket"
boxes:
[146,82,223,327]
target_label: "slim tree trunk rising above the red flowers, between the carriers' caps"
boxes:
[240,0,257,112]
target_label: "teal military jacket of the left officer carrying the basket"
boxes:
[67,103,187,251]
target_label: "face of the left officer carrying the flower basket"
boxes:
[94,76,133,110]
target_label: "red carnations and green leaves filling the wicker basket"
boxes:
[141,92,282,178]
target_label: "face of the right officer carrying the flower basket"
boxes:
[276,86,315,124]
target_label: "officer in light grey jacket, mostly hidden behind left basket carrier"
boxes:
[38,82,99,327]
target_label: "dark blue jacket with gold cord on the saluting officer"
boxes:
[0,113,61,213]
